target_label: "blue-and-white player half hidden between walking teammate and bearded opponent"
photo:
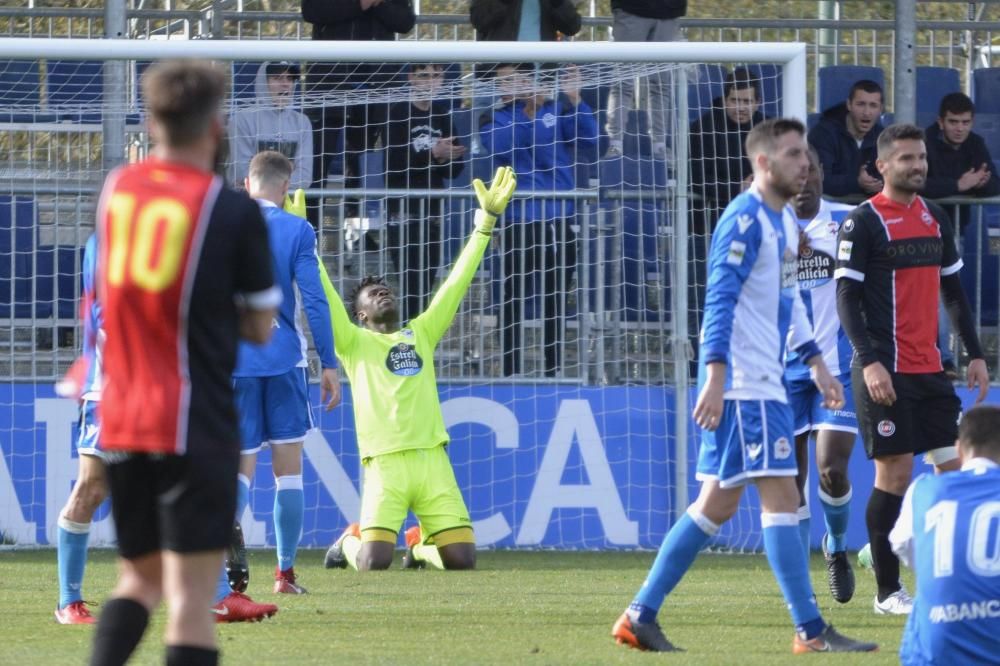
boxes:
[785,147,858,604]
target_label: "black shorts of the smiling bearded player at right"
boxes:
[851,367,962,459]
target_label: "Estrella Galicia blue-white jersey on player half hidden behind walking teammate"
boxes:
[785,199,854,381]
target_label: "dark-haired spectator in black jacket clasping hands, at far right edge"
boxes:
[923,93,1000,229]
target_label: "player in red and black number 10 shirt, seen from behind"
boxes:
[91,61,281,666]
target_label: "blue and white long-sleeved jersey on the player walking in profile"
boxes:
[699,187,819,403]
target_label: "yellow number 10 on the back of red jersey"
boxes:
[108,193,191,292]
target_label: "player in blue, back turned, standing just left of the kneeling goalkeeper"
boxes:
[222,151,340,601]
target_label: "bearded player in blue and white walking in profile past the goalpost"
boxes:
[611,118,877,654]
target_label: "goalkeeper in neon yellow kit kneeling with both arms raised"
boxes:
[321,167,517,570]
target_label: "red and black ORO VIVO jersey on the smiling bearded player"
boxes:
[835,193,962,373]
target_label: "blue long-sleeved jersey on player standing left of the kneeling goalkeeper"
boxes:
[233,199,337,377]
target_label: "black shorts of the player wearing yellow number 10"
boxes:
[108,451,239,560]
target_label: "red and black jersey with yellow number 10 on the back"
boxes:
[97,159,280,454]
